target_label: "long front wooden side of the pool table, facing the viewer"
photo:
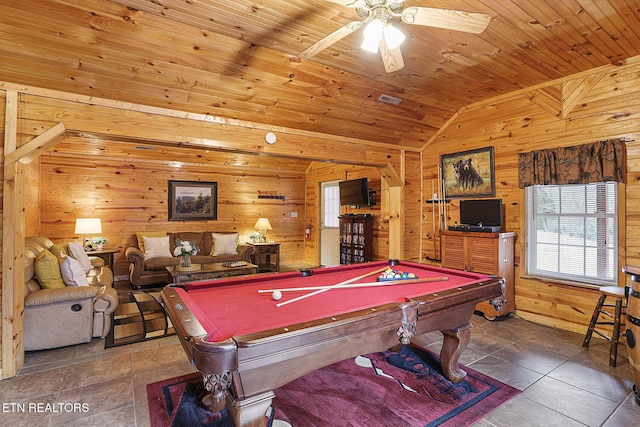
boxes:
[233,278,502,398]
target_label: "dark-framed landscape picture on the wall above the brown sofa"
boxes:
[169,181,218,221]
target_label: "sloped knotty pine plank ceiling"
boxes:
[0,0,640,148]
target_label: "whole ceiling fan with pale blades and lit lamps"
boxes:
[298,0,491,73]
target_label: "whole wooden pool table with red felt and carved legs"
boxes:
[162,260,504,426]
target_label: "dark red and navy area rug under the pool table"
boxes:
[147,346,520,427]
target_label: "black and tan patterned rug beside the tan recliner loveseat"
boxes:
[104,291,175,348]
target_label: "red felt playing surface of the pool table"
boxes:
[176,261,488,342]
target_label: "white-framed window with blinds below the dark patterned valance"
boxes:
[526,182,618,285]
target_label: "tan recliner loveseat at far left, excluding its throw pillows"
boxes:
[24,236,118,351]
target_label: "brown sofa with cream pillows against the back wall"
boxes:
[125,231,254,289]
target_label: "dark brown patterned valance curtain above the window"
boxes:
[518,139,625,188]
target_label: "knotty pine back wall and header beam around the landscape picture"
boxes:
[6,91,410,284]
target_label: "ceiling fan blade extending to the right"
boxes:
[402,7,491,34]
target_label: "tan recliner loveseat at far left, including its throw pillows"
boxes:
[24,236,118,351]
